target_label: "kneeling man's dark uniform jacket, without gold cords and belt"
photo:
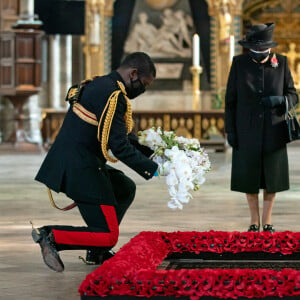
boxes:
[35,71,158,205]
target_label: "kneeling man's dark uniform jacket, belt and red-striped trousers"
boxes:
[35,71,158,250]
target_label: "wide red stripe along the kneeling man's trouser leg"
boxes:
[52,205,119,247]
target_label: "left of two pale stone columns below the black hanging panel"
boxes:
[48,34,61,109]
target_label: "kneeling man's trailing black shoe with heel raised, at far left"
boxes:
[31,228,65,272]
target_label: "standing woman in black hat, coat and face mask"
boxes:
[225,23,298,232]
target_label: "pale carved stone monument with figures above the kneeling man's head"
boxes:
[124,8,193,90]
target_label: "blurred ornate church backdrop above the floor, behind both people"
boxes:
[0,0,300,151]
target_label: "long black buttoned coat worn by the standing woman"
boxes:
[225,53,298,193]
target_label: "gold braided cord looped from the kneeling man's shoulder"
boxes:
[97,81,133,163]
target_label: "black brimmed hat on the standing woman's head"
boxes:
[238,23,277,50]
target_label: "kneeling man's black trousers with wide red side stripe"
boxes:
[46,167,136,250]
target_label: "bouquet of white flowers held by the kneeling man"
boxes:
[139,127,210,209]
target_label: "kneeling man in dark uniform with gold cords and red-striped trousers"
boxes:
[32,52,158,272]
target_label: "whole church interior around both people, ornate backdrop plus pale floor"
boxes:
[0,0,300,300]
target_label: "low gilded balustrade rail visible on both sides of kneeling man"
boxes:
[42,109,226,151]
